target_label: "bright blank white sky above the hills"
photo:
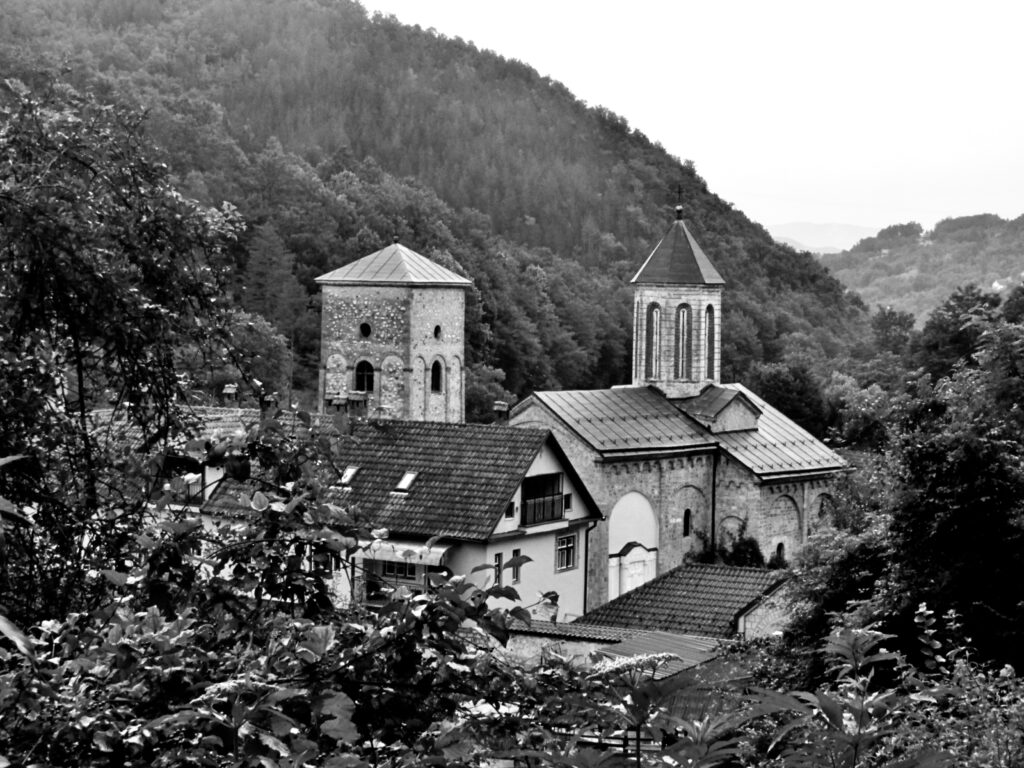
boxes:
[362,0,1024,234]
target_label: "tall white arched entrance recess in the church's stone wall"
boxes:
[608,490,658,600]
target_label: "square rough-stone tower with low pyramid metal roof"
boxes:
[316,243,472,423]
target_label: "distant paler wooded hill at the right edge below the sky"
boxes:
[821,213,1024,322]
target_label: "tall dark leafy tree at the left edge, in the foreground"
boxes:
[0,75,236,621]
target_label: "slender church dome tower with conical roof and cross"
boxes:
[630,206,725,398]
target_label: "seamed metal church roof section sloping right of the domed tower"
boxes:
[688,384,847,477]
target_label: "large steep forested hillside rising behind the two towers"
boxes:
[0,0,864,415]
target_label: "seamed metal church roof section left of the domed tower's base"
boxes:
[532,387,715,454]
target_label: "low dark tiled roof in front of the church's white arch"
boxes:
[577,563,784,638]
